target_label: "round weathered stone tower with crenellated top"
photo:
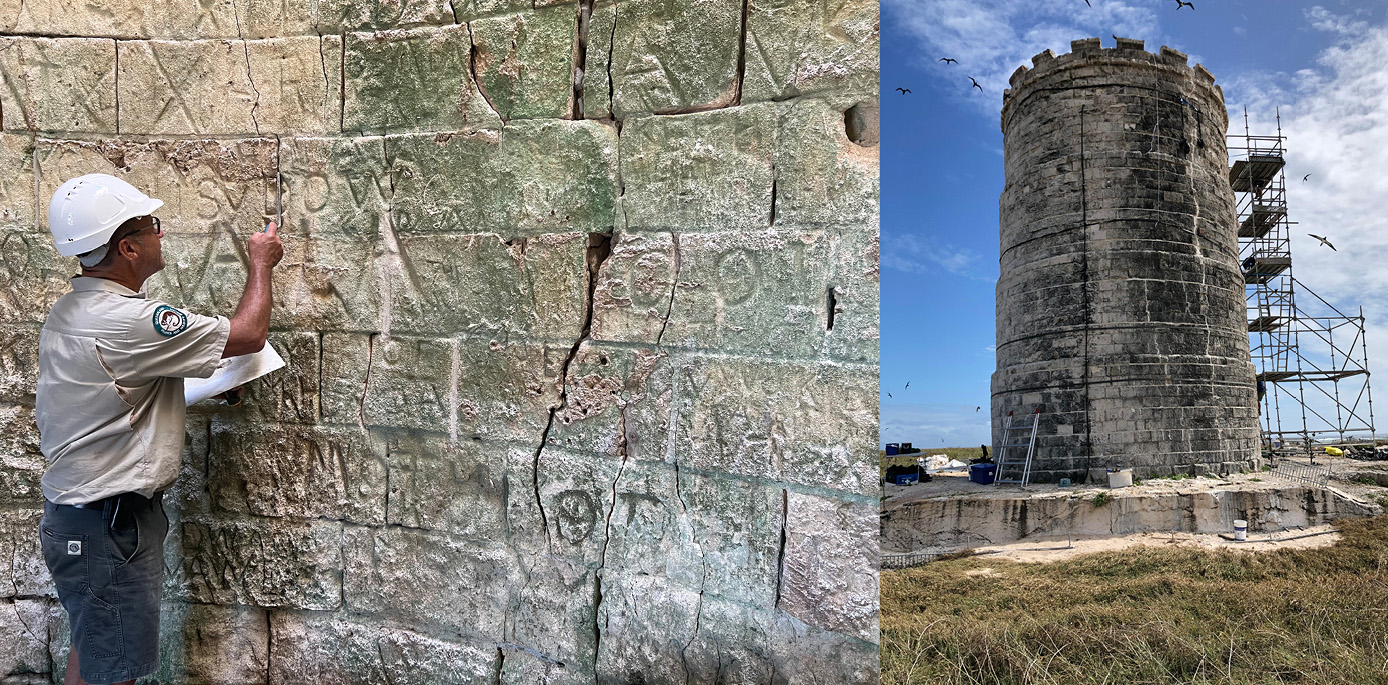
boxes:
[992,37,1259,483]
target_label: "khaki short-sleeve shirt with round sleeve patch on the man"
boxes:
[35,276,232,505]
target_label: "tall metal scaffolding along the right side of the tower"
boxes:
[1228,108,1374,452]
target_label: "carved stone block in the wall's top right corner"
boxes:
[743,0,880,103]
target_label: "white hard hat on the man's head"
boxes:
[49,173,164,266]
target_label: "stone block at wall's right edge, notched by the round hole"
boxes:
[776,100,881,227]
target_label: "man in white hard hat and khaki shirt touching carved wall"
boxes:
[35,173,285,685]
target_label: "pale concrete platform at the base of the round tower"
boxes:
[881,458,1388,553]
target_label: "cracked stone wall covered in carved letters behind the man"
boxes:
[0,0,879,684]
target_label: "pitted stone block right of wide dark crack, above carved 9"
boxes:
[547,341,672,462]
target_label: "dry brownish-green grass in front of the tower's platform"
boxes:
[881,517,1388,685]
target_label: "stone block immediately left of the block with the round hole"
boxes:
[622,104,777,232]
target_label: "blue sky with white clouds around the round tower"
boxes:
[881,0,1388,448]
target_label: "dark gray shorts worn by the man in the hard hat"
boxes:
[39,494,169,684]
